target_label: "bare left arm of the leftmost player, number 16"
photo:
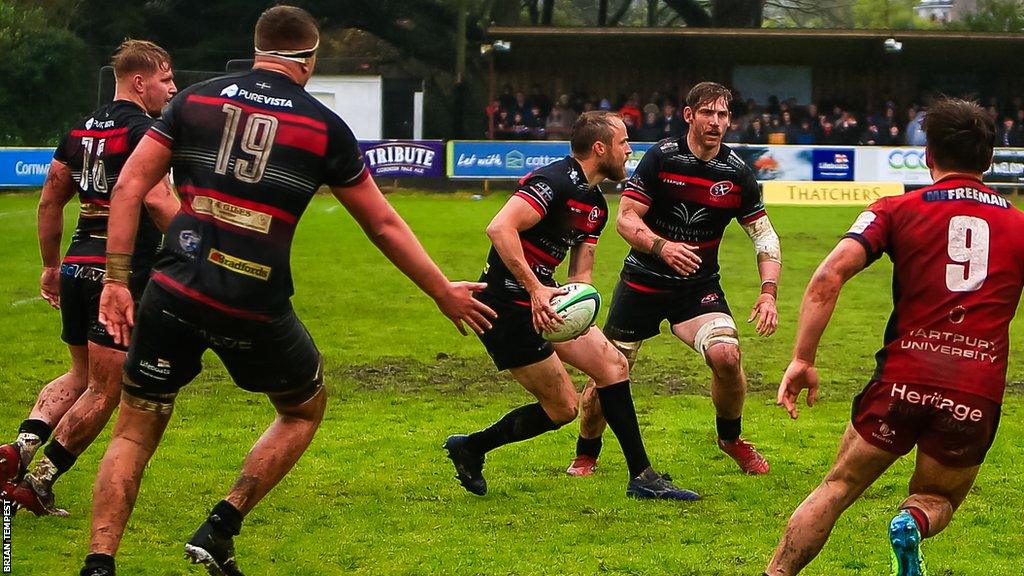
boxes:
[38,160,75,308]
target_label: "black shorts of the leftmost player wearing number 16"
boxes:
[60,263,148,352]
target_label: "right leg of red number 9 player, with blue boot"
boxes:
[889,448,981,576]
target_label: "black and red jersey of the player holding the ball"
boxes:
[481,156,608,301]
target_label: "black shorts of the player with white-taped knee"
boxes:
[604,280,732,342]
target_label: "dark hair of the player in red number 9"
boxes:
[921,97,995,173]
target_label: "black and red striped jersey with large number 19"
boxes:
[148,69,369,319]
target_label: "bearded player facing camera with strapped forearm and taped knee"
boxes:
[566,82,782,476]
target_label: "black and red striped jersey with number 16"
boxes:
[53,100,161,275]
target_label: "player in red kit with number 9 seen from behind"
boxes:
[765,98,1024,576]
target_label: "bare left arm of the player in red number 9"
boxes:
[776,238,867,419]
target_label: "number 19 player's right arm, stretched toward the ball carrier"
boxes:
[331,177,498,335]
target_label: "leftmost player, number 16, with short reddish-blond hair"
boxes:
[0,40,178,516]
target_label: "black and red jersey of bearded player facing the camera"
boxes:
[623,135,765,288]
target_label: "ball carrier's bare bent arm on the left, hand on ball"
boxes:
[487,196,565,332]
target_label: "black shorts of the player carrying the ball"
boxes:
[473,292,555,370]
